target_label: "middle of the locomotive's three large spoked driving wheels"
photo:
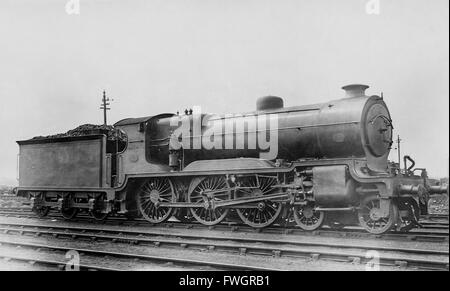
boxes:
[188,176,232,225]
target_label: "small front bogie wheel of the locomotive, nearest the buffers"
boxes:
[358,196,398,234]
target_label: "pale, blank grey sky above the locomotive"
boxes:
[0,0,449,184]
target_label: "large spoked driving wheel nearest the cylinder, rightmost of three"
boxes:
[235,176,283,228]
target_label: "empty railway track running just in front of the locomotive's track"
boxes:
[0,223,449,271]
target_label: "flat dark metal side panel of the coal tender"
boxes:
[19,138,106,188]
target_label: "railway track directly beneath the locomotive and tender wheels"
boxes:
[0,209,449,242]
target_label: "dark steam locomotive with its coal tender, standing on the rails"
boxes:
[14,85,448,234]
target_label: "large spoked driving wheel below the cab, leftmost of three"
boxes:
[136,178,176,223]
